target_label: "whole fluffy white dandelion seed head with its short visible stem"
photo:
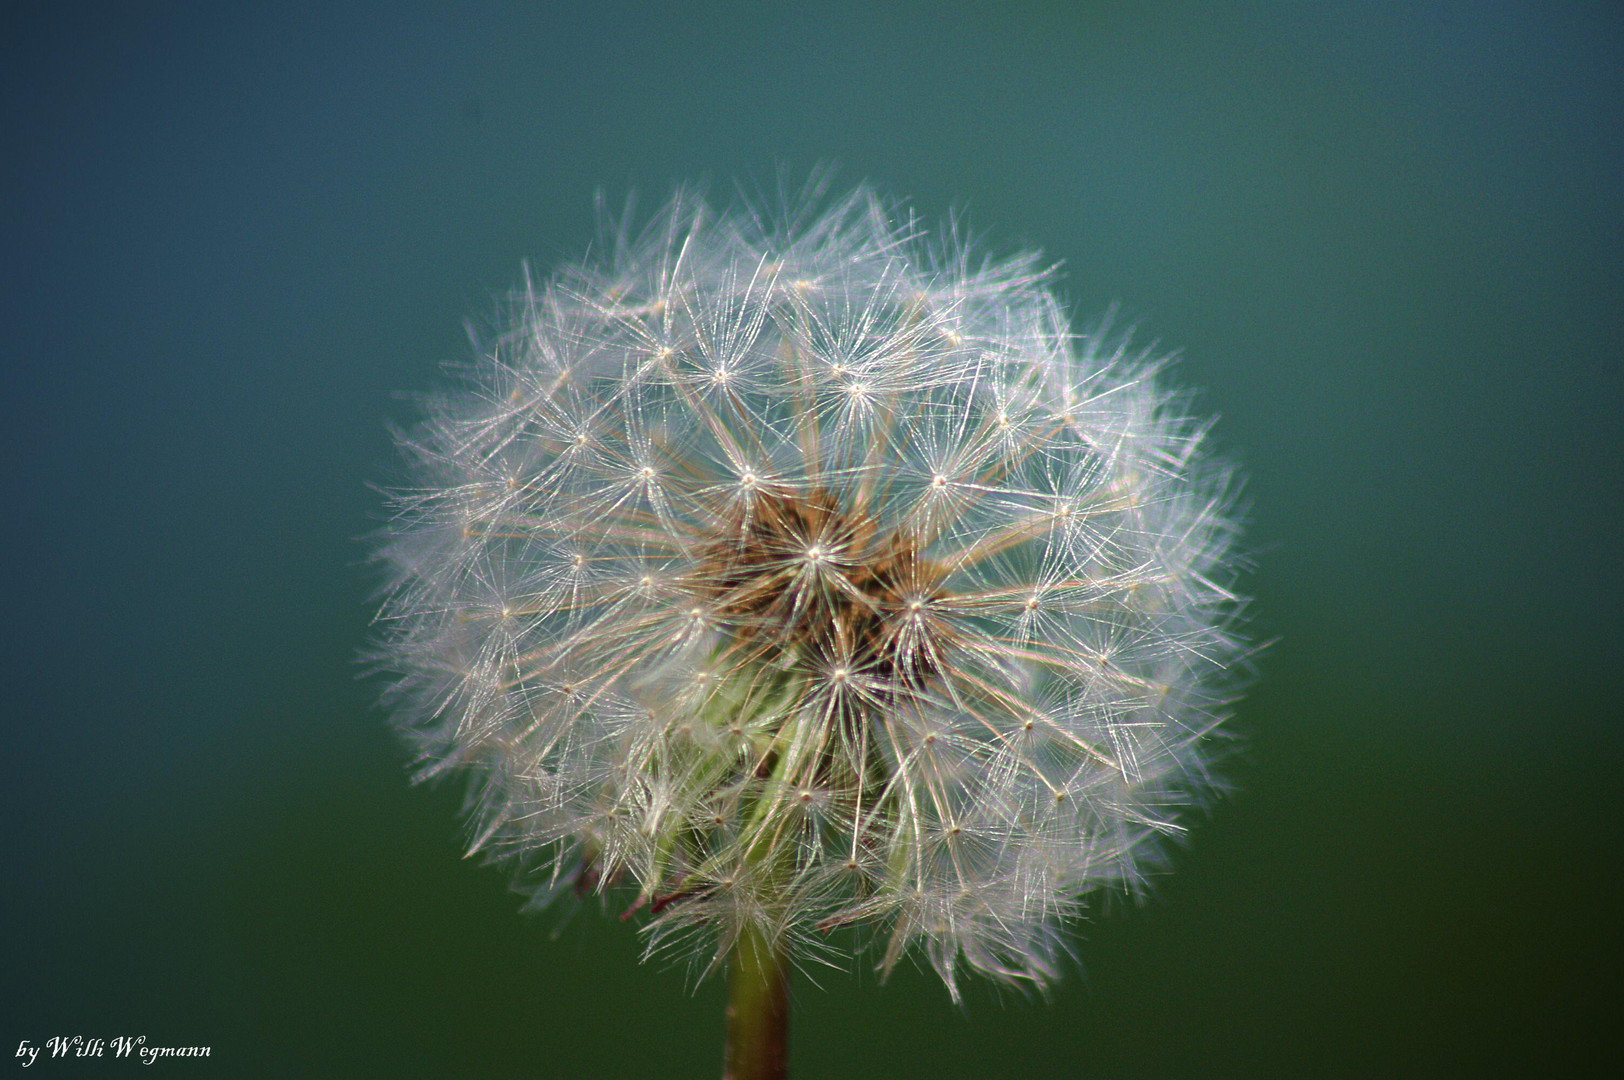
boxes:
[375,178,1242,1080]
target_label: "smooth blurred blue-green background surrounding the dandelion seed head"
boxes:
[0,0,1624,1080]
